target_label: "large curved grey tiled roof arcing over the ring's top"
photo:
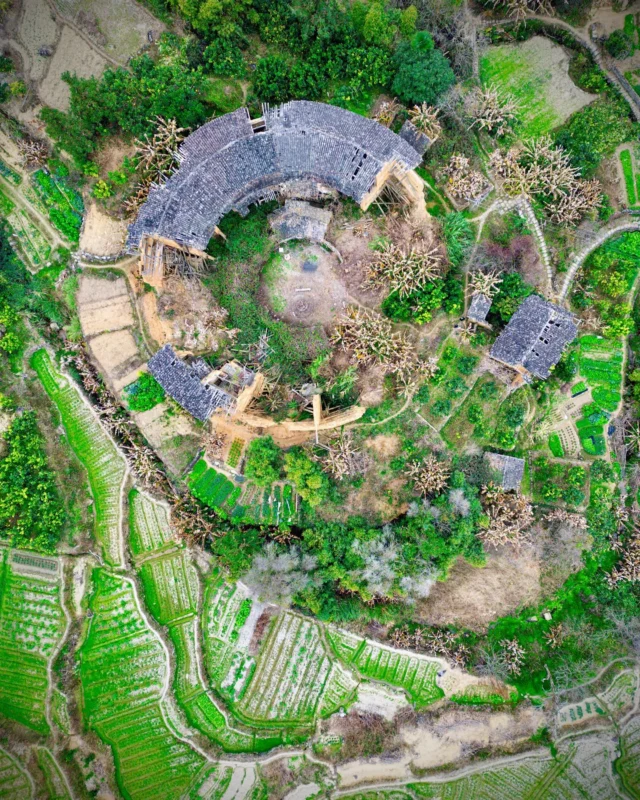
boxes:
[127,100,422,251]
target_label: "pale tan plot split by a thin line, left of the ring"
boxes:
[76,273,135,338]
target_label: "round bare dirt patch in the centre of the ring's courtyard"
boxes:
[264,244,349,327]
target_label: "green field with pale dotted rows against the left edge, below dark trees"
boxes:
[0,549,66,734]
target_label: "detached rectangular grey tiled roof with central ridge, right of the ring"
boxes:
[491,295,578,378]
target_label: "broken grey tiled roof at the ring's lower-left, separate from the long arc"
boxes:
[147,344,234,422]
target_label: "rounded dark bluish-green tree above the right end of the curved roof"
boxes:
[392,31,456,105]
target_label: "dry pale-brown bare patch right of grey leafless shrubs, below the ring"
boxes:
[416,547,541,631]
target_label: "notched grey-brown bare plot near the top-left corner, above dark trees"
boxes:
[38,25,107,111]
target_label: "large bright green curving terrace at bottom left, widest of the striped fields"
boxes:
[80,568,207,800]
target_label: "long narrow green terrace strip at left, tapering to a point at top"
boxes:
[31,350,126,566]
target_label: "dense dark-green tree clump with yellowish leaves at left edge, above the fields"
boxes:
[0,411,64,553]
